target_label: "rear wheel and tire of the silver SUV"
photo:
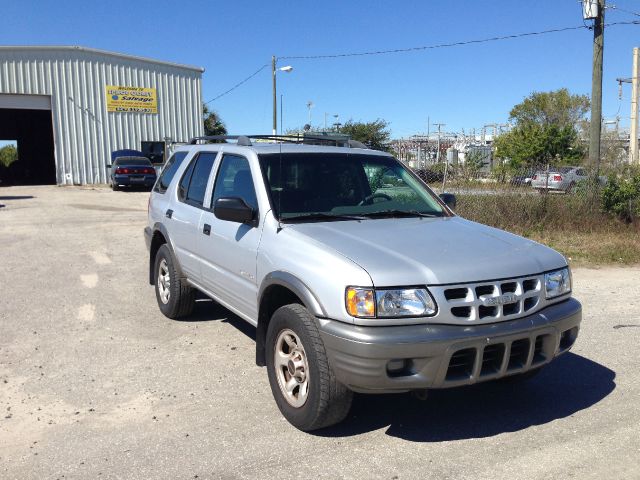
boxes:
[153,244,196,320]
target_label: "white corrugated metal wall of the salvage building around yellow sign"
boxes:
[0,48,203,184]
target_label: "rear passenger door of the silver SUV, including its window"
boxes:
[165,152,217,281]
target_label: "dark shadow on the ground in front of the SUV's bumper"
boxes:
[316,353,616,442]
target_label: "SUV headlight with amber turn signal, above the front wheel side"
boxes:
[346,287,437,318]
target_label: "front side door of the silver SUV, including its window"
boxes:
[197,153,262,320]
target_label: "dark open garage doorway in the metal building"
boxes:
[0,94,56,186]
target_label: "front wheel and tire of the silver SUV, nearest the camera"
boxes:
[266,304,353,431]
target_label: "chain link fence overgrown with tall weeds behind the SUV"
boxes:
[414,163,640,234]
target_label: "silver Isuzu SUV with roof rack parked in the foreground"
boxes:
[145,137,582,431]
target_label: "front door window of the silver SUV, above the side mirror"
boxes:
[211,155,258,208]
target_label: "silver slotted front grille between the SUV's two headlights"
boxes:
[429,275,545,323]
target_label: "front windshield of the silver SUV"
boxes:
[260,153,446,221]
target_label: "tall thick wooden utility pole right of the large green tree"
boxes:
[589,0,606,172]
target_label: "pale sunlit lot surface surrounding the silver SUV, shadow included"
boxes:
[0,187,640,479]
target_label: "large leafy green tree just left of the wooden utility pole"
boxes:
[495,88,589,168]
